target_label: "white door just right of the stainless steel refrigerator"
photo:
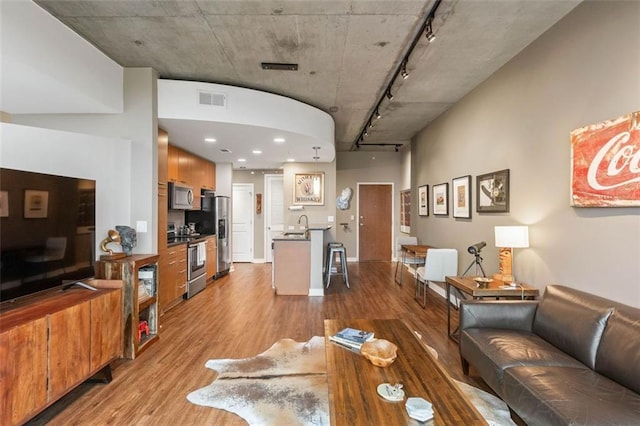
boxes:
[231,183,253,262]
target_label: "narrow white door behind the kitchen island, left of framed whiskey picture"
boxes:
[264,175,284,262]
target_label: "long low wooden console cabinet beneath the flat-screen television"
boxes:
[0,280,122,425]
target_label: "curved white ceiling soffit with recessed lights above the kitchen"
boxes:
[158,79,335,169]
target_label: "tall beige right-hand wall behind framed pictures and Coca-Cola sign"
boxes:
[412,1,640,306]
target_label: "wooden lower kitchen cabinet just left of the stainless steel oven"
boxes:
[159,244,187,314]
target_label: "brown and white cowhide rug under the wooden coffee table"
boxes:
[187,333,515,426]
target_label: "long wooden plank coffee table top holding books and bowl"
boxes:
[324,319,486,426]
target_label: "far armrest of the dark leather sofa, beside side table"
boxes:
[460,300,538,332]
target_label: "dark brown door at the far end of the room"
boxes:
[358,185,392,262]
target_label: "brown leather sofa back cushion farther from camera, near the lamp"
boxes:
[533,285,613,368]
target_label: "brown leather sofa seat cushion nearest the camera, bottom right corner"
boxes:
[501,367,640,426]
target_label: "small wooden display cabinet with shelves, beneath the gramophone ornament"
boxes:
[96,254,159,359]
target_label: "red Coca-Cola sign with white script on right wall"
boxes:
[571,112,640,207]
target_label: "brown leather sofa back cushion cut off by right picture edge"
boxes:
[595,306,640,394]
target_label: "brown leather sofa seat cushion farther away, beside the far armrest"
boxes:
[460,328,587,394]
